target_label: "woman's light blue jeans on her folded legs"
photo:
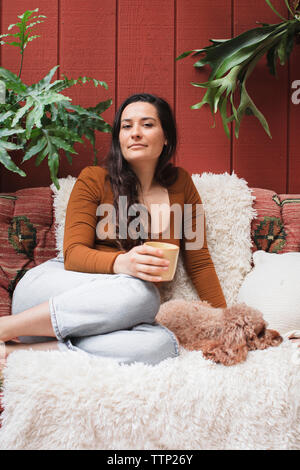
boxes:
[12,258,179,365]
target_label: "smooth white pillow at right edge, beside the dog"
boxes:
[237,250,300,336]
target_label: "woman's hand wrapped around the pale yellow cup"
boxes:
[113,244,169,282]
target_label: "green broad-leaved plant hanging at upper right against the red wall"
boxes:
[176,0,300,138]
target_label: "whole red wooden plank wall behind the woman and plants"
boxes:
[0,0,300,193]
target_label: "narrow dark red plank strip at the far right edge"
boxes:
[286,36,300,194]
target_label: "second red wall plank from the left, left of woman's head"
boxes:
[59,0,116,177]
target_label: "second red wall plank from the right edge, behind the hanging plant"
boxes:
[233,0,289,193]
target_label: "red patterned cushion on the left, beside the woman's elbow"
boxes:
[0,187,56,316]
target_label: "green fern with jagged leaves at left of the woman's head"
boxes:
[0,8,112,188]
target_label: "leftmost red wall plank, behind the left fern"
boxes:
[1,0,57,191]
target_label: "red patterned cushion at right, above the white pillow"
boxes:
[251,188,300,253]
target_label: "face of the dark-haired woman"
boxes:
[119,101,167,164]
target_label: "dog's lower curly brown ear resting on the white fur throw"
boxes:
[201,340,248,366]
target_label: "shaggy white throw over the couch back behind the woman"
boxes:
[51,172,256,305]
